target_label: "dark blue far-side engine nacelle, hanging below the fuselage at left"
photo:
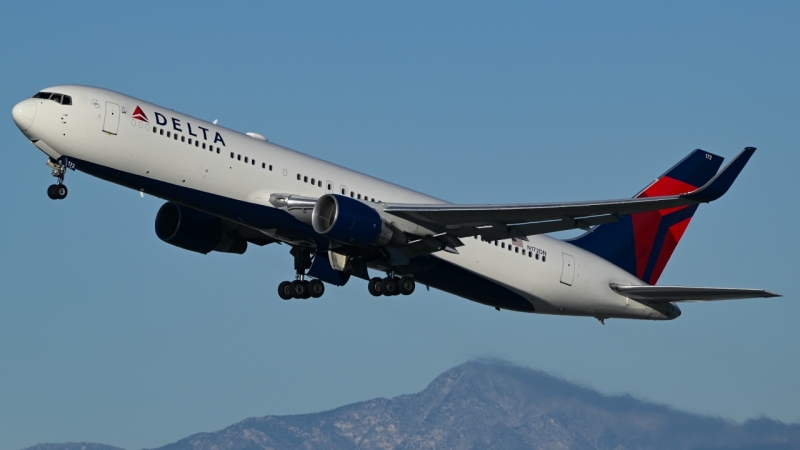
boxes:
[156,202,247,254]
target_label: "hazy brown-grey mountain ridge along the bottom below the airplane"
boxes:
[20,360,800,450]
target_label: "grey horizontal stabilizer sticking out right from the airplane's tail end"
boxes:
[608,283,780,303]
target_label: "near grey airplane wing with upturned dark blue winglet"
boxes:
[383,147,756,240]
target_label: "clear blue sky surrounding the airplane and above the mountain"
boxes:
[0,1,800,449]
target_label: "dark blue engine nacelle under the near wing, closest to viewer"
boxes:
[311,194,406,247]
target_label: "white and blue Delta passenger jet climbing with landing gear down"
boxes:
[12,85,778,324]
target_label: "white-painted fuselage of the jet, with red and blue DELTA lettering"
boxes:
[15,85,680,320]
